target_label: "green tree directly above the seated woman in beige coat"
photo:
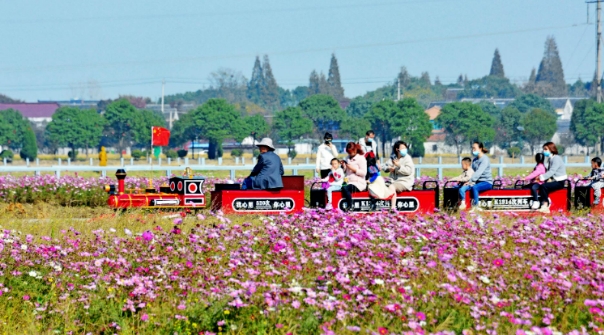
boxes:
[392,98,432,157]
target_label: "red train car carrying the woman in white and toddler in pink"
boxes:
[310,181,440,214]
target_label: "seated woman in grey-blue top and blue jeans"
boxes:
[459,142,493,211]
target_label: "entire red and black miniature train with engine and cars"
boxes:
[105,169,604,215]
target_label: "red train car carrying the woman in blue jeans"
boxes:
[443,180,571,215]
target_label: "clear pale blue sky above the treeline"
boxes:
[0,0,596,102]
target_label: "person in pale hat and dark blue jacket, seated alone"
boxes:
[241,137,284,190]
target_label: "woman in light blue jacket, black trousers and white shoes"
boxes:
[539,142,568,213]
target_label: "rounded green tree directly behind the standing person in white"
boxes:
[300,94,346,136]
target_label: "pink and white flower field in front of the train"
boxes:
[0,207,604,334]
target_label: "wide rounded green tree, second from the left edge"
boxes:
[46,106,105,155]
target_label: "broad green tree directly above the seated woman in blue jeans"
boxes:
[436,102,495,155]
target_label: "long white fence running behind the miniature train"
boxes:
[0,156,591,179]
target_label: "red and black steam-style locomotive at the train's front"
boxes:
[105,169,206,209]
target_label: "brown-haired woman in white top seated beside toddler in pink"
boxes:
[342,142,367,211]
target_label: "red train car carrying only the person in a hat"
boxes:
[210,176,304,215]
